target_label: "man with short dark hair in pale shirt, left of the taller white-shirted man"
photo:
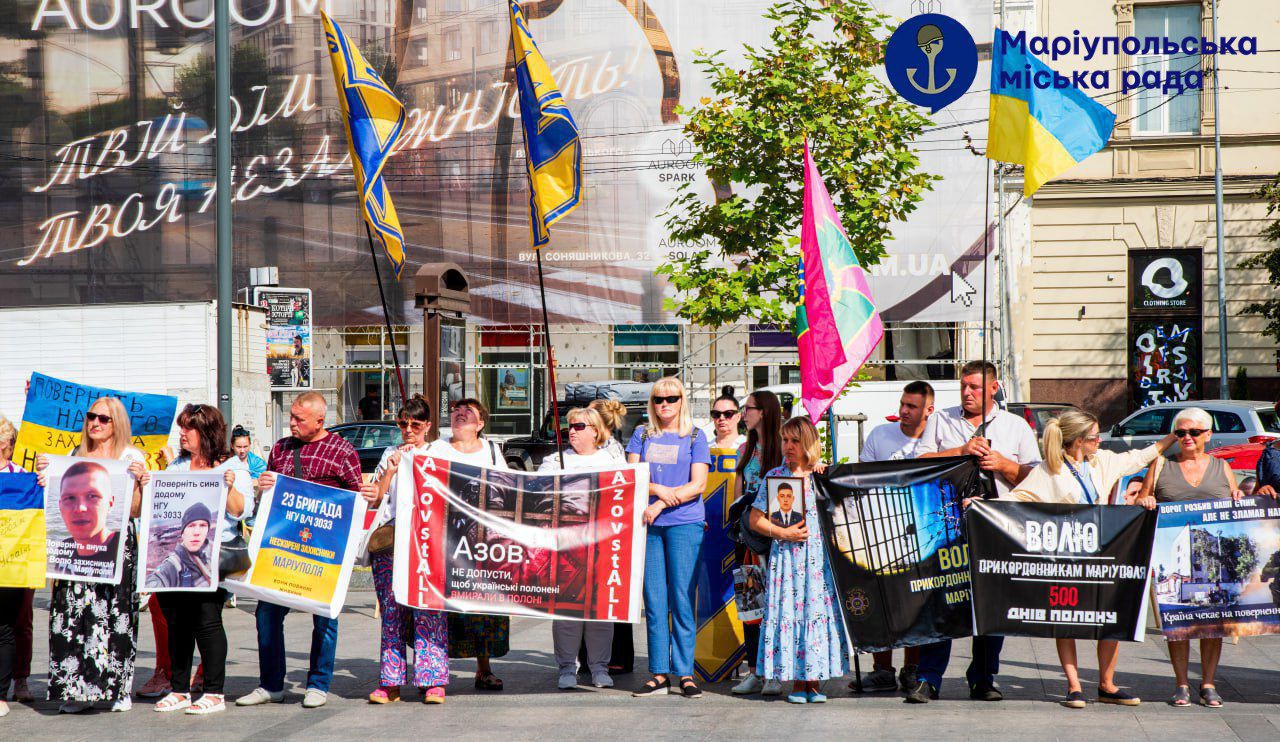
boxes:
[850,381,933,693]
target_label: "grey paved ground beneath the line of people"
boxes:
[0,591,1280,742]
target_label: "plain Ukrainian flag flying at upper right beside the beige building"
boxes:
[987,28,1116,196]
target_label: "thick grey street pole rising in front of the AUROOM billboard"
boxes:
[214,0,233,422]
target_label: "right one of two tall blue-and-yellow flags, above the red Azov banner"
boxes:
[508,0,582,248]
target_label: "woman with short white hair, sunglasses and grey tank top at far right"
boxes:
[1138,407,1243,709]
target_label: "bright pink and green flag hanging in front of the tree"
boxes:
[795,142,884,421]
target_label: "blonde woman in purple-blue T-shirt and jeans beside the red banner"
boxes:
[627,376,712,699]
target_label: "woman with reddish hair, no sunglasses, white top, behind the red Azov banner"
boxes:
[426,398,511,691]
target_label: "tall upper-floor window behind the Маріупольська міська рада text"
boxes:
[1133,3,1201,134]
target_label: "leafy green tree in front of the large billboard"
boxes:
[658,0,934,326]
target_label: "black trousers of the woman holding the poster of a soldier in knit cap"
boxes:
[156,590,227,695]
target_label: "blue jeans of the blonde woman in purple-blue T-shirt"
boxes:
[644,523,705,677]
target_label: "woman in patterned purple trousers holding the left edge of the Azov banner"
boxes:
[360,394,449,704]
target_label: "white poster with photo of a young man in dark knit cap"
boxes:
[138,472,227,592]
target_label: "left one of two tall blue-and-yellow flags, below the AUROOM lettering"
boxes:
[320,10,404,280]
